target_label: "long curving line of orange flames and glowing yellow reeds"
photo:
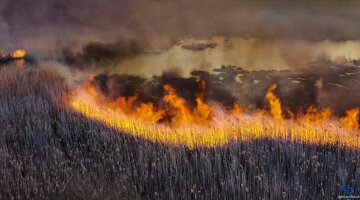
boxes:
[68,80,360,149]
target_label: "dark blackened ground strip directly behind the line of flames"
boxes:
[89,63,360,115]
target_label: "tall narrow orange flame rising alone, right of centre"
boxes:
[266,83,283,121]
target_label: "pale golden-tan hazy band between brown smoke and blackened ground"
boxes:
[100,37,360,76]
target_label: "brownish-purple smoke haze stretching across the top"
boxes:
[0,0,360,52]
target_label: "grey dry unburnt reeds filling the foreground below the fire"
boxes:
[0,66,360,199]
